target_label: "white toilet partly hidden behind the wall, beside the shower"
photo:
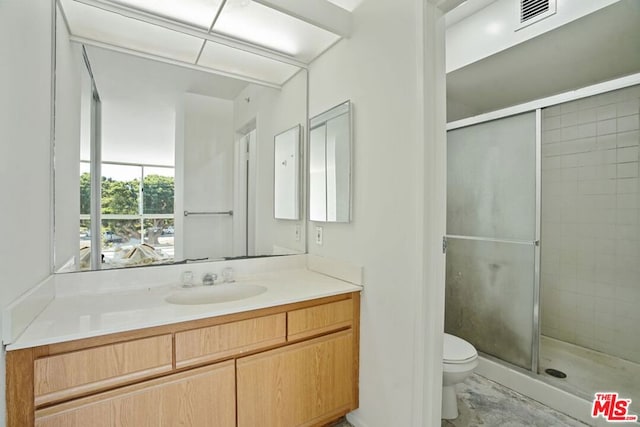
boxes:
[442,334,478,420]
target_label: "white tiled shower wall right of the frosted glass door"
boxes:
[541,86,640,363]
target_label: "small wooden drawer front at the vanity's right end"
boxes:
[287,299,353,340]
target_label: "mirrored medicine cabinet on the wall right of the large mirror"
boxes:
[309,101,351,222]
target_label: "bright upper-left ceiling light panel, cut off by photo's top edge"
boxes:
[113,0,222,31]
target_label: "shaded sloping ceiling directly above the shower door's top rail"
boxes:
[447,0,640,121]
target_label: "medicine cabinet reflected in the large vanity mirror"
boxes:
[273,125,302,220]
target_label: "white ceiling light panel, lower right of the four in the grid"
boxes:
[198,41,300,85]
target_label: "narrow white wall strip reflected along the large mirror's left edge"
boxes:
[54,7,83,270]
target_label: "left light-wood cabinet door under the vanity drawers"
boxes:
[35,360,236,427]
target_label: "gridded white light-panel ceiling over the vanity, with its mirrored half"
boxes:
[58,0,353,87]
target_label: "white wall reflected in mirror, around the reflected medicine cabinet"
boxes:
[234,71,307,255]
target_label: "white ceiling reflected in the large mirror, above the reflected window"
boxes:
[83,46,258,165]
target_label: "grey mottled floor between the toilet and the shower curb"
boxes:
[442,374,586,427]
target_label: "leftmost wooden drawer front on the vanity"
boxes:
[33,334,172,406]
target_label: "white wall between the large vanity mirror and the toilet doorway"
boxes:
[308,0,444,427]
